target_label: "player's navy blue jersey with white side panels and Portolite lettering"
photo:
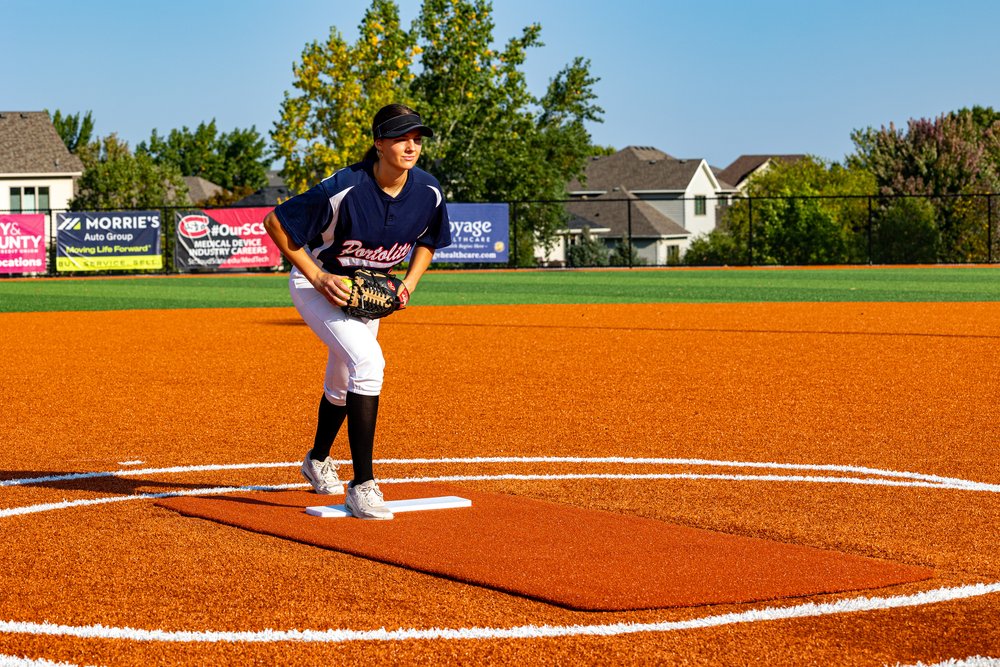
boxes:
[274,162,451,275]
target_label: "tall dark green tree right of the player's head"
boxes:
[413,0,603,265]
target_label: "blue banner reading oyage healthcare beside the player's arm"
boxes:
[434,203,510,263]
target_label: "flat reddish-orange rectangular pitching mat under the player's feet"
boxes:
[157,483,932,611]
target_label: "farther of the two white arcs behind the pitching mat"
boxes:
[0,456,1000,490]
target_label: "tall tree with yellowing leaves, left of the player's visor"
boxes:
[271,0,420,192]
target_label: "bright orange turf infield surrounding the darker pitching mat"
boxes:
[0,303,1000,665]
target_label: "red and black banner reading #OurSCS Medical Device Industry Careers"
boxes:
[174,207,281,271]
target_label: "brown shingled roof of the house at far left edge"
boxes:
[0,111,83,175]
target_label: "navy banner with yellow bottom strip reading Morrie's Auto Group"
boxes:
[56,211,163,271]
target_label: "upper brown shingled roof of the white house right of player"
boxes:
[566,146,702,192]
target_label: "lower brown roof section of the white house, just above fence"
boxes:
[566,186,691,238]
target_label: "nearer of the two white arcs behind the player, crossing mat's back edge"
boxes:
[0,464,1000,519]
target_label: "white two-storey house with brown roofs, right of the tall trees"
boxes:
[538,146,736,265]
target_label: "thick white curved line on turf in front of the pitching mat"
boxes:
[0,582,1000,643]
